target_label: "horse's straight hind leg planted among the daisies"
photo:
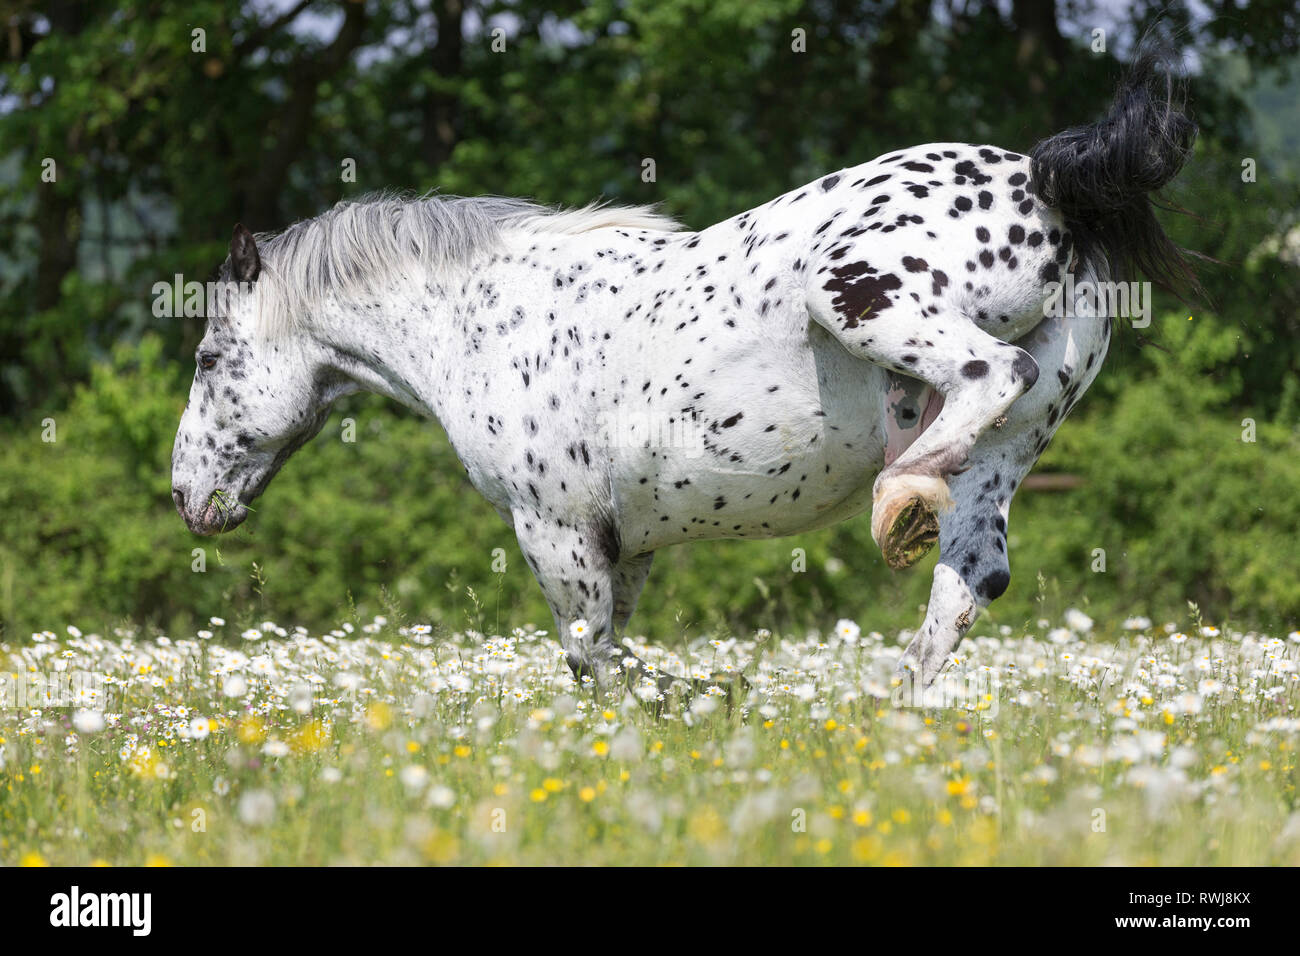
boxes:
[900,303,1110,685]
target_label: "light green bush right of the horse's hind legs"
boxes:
[1011,315,1300,627]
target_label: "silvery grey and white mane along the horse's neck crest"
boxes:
[243,194,680,334]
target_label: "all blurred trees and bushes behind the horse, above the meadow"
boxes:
[0,0,1300,640]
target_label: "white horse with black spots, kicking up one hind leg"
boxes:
[172,62,1195,693]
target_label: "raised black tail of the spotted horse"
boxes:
[1030,53,1204,300]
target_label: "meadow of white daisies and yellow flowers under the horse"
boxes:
[0,610,1300,865]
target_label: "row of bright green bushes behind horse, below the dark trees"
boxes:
[0,325,1300,641]
